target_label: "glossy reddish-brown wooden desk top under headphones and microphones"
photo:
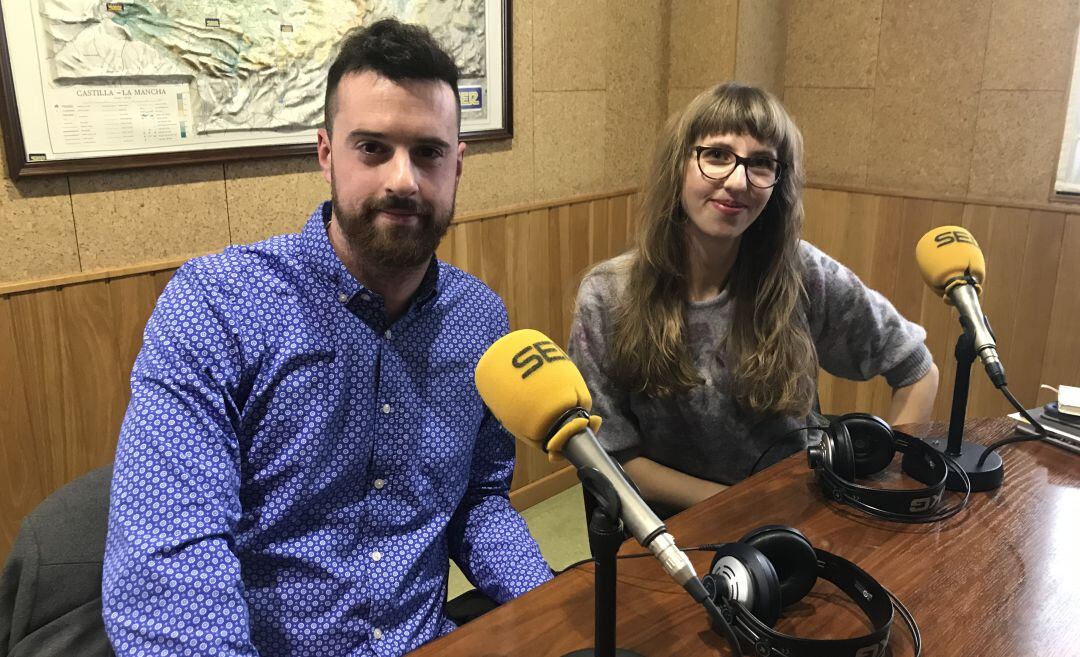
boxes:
[413,419,1080,657]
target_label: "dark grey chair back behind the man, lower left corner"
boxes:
[0,465,113,657]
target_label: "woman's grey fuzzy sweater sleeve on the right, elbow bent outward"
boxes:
[800,242,933,388]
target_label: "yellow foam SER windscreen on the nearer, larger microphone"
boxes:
[475,329,593,450]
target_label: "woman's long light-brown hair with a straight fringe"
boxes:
[611,82,818,417]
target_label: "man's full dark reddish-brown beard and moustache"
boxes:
[330,183,454,271]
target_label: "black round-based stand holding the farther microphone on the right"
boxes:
[927,331,1005,491]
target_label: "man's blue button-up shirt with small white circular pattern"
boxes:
[103,203,551,657]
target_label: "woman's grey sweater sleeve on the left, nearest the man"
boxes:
[567,264,642,461]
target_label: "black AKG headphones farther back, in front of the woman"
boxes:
[807,413,971,522]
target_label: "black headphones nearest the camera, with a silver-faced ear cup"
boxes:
[702,525,922,657]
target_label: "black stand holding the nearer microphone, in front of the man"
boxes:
[563,468,643,657]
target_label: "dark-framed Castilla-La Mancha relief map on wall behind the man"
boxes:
[0,0,512,178]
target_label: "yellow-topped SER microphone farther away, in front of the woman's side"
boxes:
[915,226,1005,388]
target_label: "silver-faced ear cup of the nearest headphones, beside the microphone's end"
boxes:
[707,542,781,628]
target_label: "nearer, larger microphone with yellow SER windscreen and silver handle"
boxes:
[475,329,708,602]
